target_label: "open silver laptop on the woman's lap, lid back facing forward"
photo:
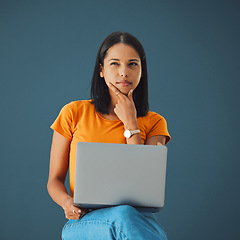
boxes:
[74,142,167,212]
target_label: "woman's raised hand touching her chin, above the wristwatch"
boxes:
[108,83,137,128]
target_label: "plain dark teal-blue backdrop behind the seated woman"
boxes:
[0,0,240,240]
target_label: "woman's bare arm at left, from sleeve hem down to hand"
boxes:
[47,131,88,219]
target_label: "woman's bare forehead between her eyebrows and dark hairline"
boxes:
[105,43,140,60]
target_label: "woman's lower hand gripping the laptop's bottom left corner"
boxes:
[63,197,89,219]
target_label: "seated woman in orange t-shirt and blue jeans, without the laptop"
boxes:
[47,32,170,240]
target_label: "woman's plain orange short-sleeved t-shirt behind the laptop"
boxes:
[51,100,171,196]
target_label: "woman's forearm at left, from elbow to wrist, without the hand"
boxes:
[47,179,71,209]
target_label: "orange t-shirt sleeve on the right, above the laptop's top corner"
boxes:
[147,112,171,144]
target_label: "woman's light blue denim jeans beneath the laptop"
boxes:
[62,205,167,240]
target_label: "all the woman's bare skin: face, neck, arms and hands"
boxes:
[47,43,166,219]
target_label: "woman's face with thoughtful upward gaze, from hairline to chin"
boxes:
[100,43,142,95]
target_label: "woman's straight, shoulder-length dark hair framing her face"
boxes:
[91,31,149,117]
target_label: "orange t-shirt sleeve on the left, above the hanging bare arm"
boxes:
[50,103,73,141]
